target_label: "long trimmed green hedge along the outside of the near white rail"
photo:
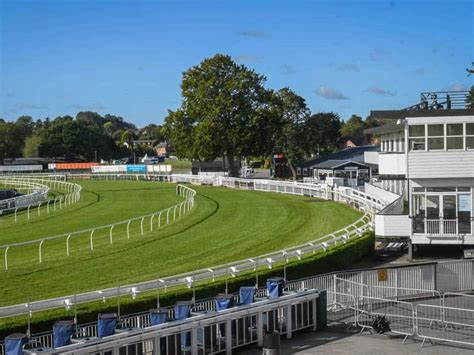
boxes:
[0,232,375,339]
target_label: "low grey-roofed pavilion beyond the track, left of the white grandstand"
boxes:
[297,145,380,185]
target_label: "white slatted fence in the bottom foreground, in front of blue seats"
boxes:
[3,290,319,354]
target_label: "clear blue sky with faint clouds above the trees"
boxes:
[0,0,474,126]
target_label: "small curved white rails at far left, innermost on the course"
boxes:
[0,176,82,222]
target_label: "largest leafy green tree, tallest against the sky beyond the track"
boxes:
[163,54,267,176]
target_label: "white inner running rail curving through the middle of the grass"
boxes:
[0,185,196,272]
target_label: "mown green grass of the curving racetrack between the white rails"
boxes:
[0,181,361,305]
